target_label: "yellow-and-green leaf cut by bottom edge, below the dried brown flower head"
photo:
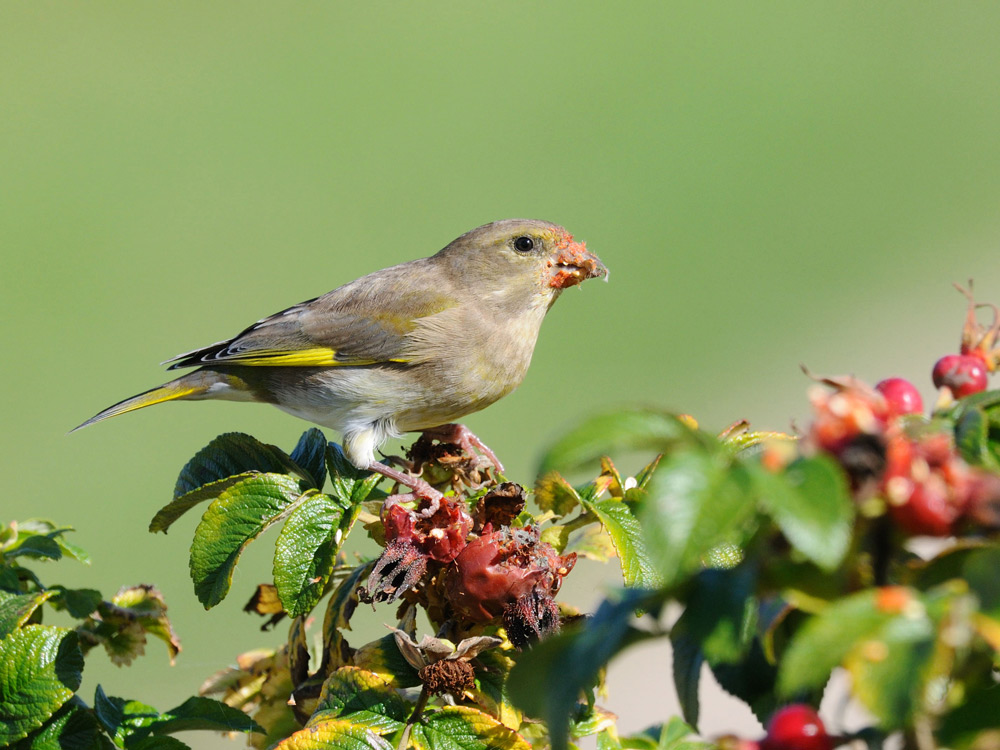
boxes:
[410,706,531,750]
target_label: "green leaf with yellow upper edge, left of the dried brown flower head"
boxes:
[308,667,411,735]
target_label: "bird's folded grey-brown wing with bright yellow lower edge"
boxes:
[164,262,457,369]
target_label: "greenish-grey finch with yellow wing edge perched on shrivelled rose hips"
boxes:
[73,219,608,505]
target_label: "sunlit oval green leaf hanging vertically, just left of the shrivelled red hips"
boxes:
[273,495,344,617]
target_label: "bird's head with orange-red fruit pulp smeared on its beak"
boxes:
[438,219,608,307]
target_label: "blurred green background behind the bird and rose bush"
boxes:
[0,0,1000,747]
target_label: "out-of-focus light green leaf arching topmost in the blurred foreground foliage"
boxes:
[538,409,702,476]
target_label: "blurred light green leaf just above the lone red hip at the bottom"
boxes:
[778,590,896,697]
